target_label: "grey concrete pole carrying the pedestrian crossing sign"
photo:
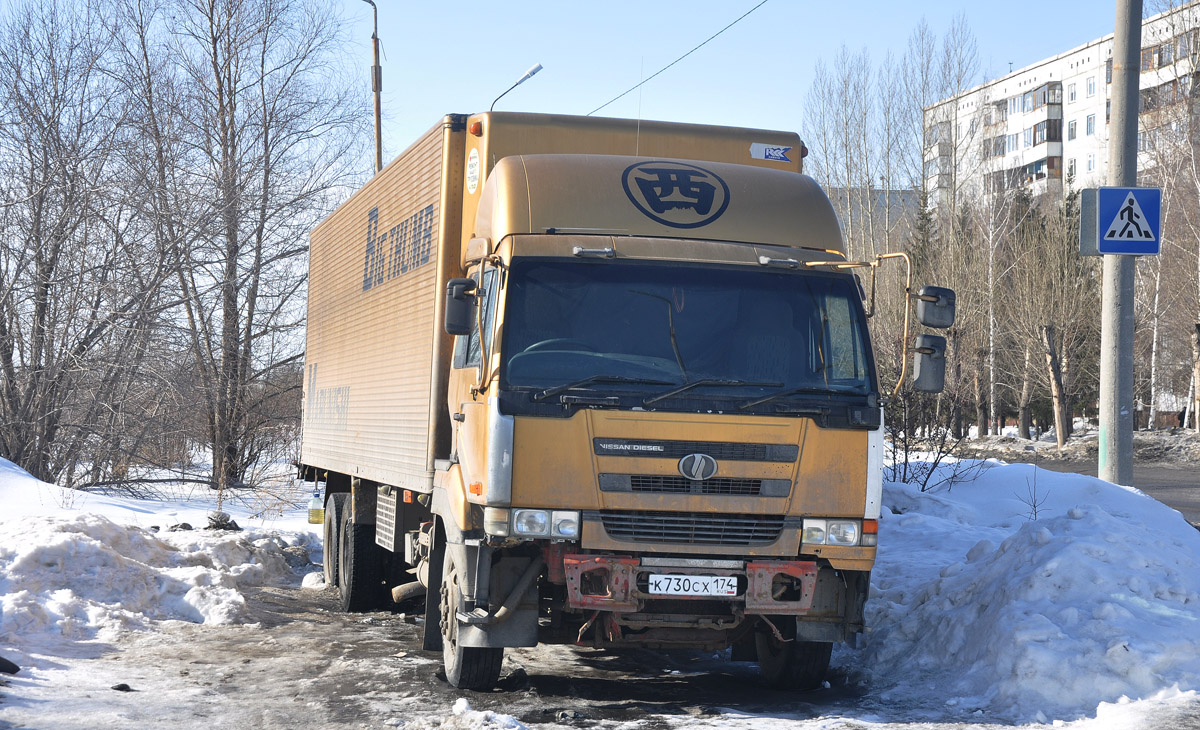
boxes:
[1098,0,1141,486]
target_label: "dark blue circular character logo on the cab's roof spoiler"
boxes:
[620,160,730,228]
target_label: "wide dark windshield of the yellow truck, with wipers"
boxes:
[500,261,872,405]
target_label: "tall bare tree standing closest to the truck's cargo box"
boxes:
[143,0,366,486]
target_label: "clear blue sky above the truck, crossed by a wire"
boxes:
[343,0,1128,161]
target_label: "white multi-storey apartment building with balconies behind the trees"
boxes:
[924,0,1200,208]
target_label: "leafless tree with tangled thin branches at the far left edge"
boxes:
[0,0,175,484]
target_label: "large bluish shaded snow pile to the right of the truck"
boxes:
[864,465,1200,720]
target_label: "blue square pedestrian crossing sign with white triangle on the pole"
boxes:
[1096,187,1163,256]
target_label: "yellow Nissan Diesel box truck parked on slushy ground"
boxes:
[300,113,954,689]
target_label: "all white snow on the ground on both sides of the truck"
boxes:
[0,460,1200,730]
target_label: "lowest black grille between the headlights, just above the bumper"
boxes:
[600,510,784,546]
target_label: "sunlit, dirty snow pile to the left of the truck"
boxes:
[0,460,314,658]
